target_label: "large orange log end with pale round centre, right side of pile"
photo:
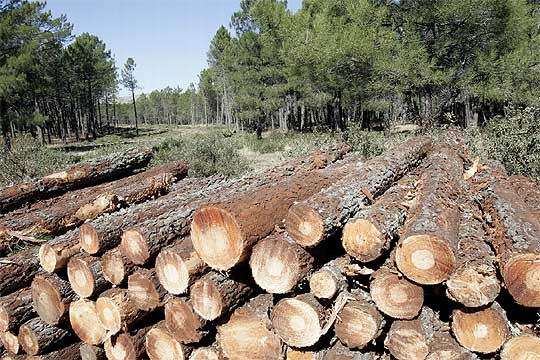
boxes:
[396,235,456,285]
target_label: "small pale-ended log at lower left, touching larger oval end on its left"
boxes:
[95,289,147,334]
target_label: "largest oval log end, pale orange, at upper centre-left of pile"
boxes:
[191,206,244,270]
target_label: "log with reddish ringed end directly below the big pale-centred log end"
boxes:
[369,252,424,320]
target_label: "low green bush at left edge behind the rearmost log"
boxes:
[0,135,80,186]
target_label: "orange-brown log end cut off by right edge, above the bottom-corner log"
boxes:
[502,254,540,307]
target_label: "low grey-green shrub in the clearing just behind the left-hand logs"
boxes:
[154,132,249,177]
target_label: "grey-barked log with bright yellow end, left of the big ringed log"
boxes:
[342,174,418,262]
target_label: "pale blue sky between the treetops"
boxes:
[47,0,301,95]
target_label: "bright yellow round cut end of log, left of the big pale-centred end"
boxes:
[342,219,386,262]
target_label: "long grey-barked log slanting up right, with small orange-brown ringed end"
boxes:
[285,137,431,247]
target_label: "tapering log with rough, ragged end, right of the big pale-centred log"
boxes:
[446,185,501,307]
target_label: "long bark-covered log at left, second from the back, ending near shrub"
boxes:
[0,162,187,236]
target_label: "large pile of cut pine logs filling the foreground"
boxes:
[0,135,540,360]
